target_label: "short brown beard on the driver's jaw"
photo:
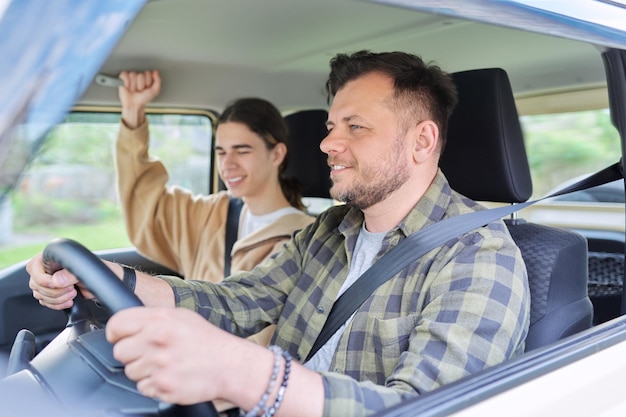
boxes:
[330,137,410,210]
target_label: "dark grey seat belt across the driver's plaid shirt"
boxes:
[305,160,624,362]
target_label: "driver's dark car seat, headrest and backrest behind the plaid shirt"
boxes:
[439,68,593,351]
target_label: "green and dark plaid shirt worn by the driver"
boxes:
[164,168,530,416]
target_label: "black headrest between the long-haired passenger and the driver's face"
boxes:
[285,109,331,198]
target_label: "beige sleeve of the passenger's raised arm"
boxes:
[116,122,222,275]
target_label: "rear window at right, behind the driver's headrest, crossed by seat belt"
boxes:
[520,108,626,232]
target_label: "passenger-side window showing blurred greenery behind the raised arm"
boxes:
[0,111,213,268]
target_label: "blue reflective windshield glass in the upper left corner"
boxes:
[0,0,145,200]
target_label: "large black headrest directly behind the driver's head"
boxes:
[439,68,532,203]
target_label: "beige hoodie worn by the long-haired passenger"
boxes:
[116,122,313,344]
